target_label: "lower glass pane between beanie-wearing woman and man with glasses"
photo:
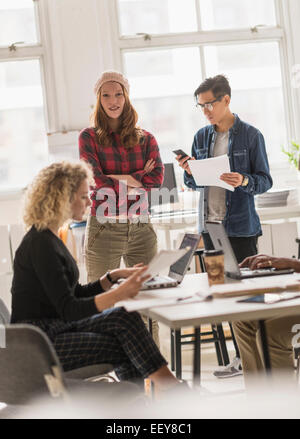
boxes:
[124,48,201,167]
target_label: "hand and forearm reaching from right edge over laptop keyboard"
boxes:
[239,254,300,272]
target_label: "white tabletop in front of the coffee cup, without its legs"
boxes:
[143,273,300,329]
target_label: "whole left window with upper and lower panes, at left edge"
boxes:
[0,0,48,190]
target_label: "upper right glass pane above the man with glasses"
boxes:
[199,0,276,30]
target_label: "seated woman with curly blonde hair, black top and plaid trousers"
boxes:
[11,162,178,396]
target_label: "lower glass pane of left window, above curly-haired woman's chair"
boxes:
[0,60,48,189]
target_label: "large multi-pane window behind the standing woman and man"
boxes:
[115,0,293,187]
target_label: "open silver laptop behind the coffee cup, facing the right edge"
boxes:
[206,221,294,279]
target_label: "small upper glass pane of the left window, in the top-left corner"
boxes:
[0,0,37,46]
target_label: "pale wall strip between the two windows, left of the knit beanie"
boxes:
[47,0,114,132]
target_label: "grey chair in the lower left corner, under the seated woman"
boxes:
[0,324,138,405]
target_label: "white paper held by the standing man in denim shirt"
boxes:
[188,154,234,192]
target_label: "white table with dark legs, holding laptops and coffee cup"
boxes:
[139,273,300,382]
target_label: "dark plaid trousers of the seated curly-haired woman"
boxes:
[20,308,167,381]
